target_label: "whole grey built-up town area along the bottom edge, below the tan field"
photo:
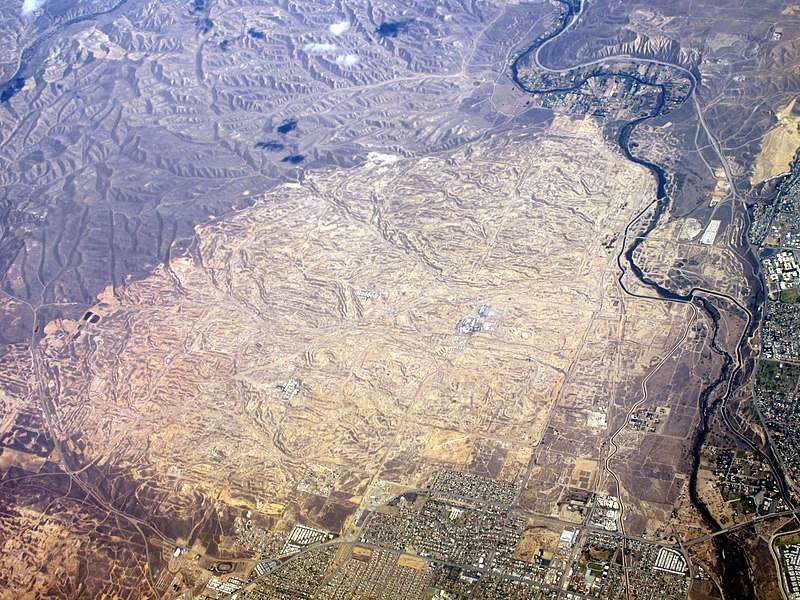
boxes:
[198,471,688,600]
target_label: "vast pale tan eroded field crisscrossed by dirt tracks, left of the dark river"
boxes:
[0,119,702,589]
